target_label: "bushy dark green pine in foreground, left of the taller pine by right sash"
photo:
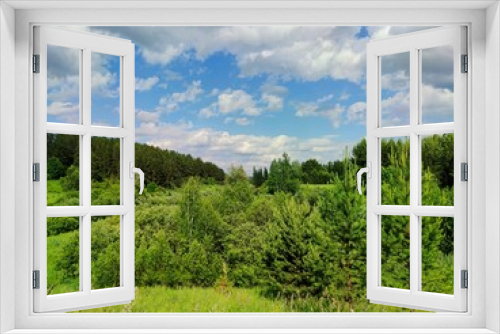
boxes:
[264,193,333,298]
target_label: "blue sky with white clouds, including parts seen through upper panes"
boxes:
[47,26,453,172]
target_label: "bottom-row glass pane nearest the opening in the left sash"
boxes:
[91,216,120,289]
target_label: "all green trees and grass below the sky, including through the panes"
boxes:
[47,134,453,312]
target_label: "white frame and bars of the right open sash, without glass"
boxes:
[367,26,470,312]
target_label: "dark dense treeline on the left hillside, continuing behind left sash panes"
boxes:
[47,134,225,189]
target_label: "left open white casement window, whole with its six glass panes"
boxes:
[34,27,135,312]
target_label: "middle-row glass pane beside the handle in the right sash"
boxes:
[381,137,410,205]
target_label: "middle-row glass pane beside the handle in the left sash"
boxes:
[91,137,121,205]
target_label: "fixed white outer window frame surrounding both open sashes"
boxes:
[0,1,500,333]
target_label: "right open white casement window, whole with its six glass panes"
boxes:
[367,27,467,311]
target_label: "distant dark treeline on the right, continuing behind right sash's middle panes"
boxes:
[252,134,454,188]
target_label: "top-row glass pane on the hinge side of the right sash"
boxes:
[421,45,453,124]
